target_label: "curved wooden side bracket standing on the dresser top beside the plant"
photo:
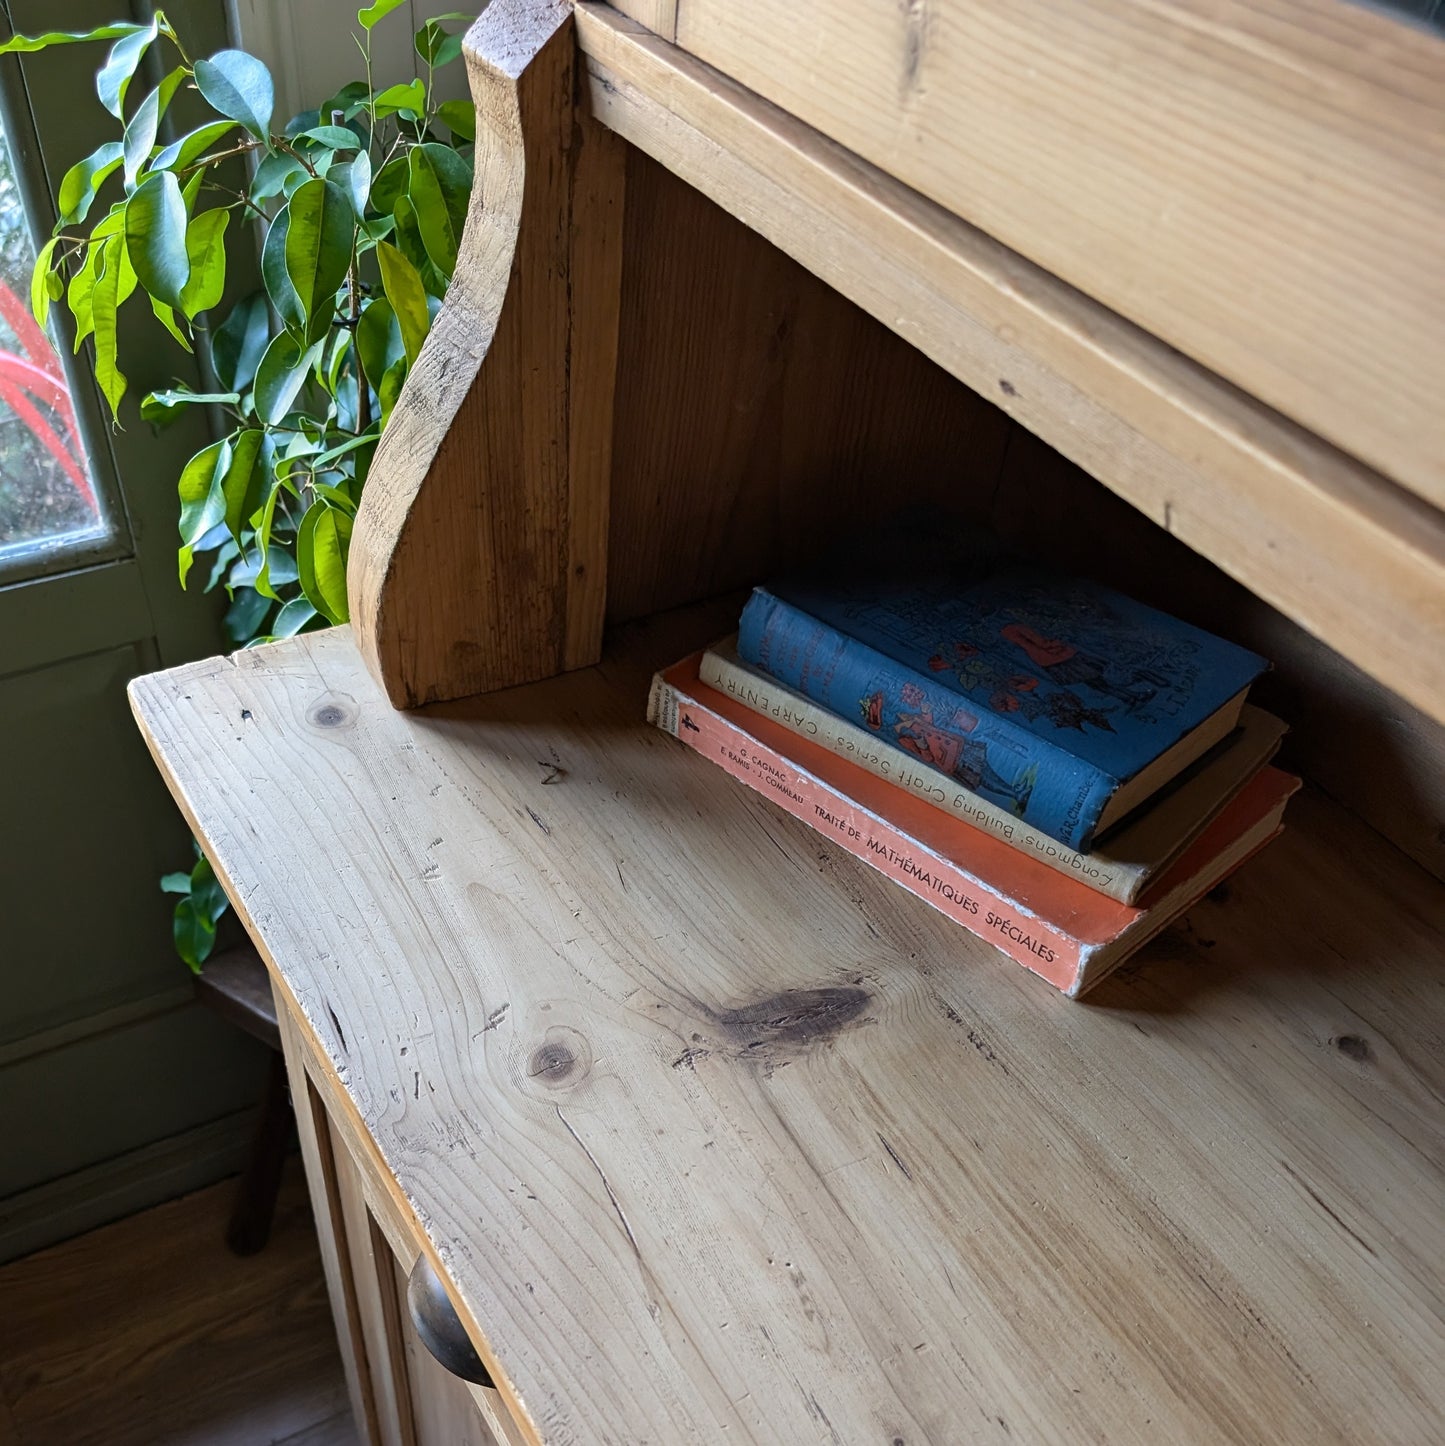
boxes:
[349,0,623,707]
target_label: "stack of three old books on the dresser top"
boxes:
[648,525,1299,996]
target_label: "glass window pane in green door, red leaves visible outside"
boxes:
[0,101,110,562]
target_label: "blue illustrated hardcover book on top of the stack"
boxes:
[738,525,1269,850]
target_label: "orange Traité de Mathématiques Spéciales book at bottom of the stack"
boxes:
[648,654,1299,996]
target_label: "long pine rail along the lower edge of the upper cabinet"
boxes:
[576,3,1445,720]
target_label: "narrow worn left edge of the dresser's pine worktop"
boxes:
[126,658,545,1446]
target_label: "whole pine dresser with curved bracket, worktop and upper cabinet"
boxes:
[132,0,1445,1446]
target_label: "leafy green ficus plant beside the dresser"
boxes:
[0,0,476,969]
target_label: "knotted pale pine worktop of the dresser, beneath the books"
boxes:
[133,613,1445,1446]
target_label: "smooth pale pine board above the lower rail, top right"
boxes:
[677,0,1445,505]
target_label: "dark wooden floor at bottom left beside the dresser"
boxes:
[0,1161,356,1446]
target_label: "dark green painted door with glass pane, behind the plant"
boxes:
[0,0,265,1259]
